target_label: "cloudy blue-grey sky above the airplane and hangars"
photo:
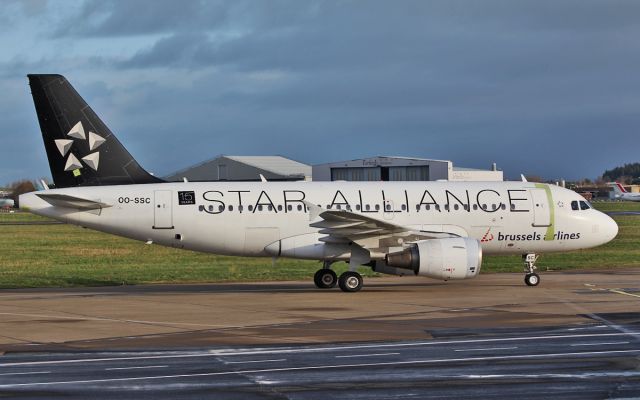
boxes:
[0,0,640,185]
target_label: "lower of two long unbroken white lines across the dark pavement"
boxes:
[0,349,640,388]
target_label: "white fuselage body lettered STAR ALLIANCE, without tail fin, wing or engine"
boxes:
[20,182,618,259]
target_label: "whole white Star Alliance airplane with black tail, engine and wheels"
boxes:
[20,74,618,292]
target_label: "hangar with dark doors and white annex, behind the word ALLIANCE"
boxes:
[313,156,503,181]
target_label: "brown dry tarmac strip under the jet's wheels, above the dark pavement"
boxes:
[0,268,640,352]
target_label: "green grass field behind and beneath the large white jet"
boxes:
[0,202,640,288]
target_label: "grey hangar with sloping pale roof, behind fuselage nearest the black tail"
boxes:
[165,156,311,182]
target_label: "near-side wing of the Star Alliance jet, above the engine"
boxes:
[307,203,459,253]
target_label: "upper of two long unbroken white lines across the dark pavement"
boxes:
[0,331,640,368]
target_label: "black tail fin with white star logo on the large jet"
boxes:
[28,75,163,188]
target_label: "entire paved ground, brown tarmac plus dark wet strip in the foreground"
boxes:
[0,269,640,399]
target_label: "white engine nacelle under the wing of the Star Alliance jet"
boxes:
[385,238,482,281]
